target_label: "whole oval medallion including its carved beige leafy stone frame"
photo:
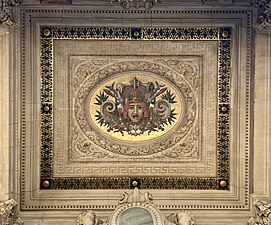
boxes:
[74,61,196,156]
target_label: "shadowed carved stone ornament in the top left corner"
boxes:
[0,0,23,27]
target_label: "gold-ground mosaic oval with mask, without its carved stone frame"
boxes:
[89,73,183,141]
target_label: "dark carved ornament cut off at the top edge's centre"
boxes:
[110,0,165,10]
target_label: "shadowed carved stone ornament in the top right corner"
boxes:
[255,0,271,30]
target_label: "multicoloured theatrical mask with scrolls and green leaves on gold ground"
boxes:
[95,77,176,136]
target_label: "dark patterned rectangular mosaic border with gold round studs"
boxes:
[40,26,232,190]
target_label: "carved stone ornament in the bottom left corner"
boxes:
[0,199,24,225]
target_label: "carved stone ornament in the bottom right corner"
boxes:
[247,200,271,225]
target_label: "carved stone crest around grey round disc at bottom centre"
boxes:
[76,188,195,225]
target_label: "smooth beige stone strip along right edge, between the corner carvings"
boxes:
[253,30,271,197]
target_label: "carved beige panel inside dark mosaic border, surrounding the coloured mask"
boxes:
[54,41,217,176]
